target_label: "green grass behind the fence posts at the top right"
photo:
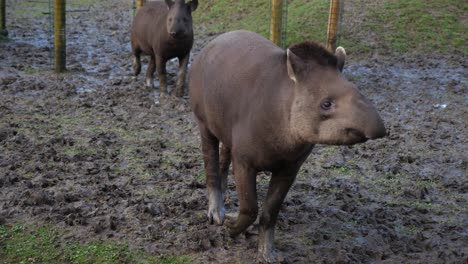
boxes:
[194,0,468,55]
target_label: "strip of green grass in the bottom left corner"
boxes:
[0,224,194,264]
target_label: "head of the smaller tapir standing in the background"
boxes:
[165,0,198,39]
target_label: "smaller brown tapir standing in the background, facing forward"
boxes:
[131,0,198,97]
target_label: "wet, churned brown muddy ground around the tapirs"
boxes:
[0,0,468,263]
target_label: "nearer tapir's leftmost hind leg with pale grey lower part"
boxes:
[199,124,225,225]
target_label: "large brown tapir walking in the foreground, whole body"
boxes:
[189,30,386,262]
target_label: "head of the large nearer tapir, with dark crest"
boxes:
[286,42,386,145]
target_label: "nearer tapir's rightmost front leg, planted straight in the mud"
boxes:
[257,167,299,263]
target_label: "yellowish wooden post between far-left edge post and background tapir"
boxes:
[54,0,67,73]
